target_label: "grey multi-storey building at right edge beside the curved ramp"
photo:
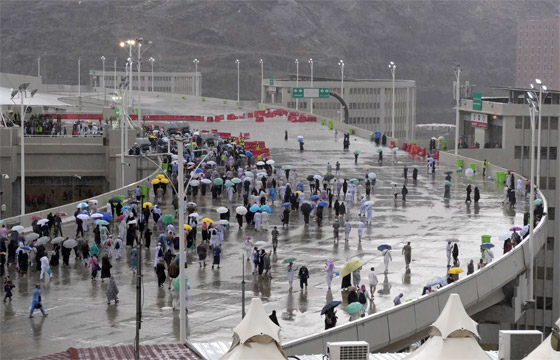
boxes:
[459,88,560,333]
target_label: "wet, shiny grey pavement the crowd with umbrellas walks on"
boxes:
[0,118,525,359]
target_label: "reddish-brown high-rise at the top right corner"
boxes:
[515,17,560,90]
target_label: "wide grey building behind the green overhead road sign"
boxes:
[263,76,416,139]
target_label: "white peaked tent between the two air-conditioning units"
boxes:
[404,294,490,360]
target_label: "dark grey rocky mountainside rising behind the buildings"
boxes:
[0,0,560,123]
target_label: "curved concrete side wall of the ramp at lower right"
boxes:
[282,153,548,355]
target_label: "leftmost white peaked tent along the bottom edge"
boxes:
[221,298,287,360]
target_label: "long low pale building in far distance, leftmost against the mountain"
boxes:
[89,69,202,96]
